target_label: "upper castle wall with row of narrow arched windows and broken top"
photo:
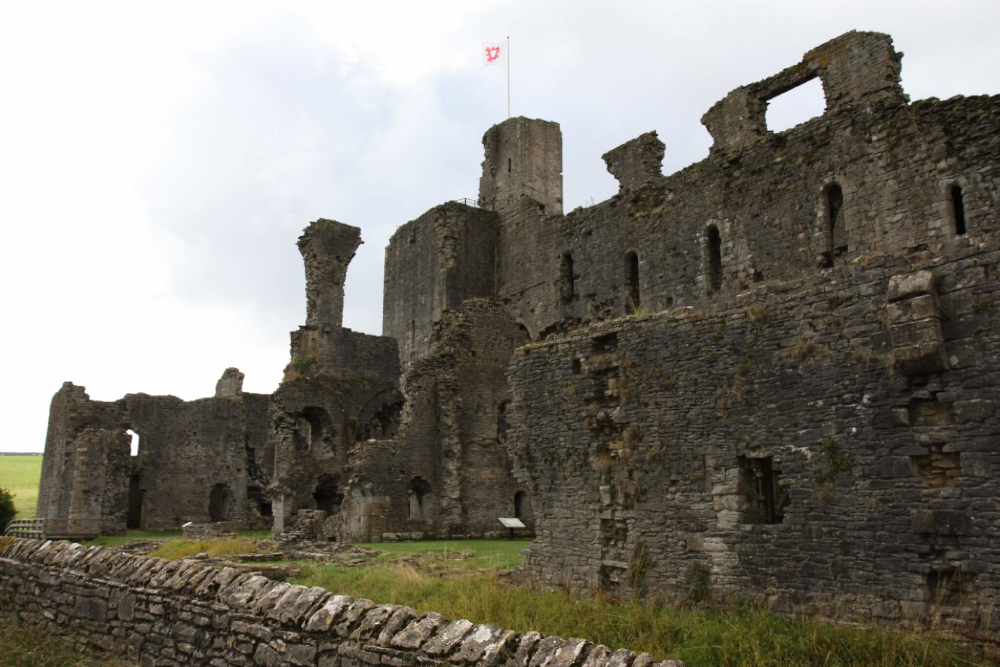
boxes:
[491,33,1000,339]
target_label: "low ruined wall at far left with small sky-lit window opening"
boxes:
[36,382,273,538]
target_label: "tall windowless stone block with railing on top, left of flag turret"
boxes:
[382,202,497,366]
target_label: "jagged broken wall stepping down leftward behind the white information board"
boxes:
[325,299,533,542]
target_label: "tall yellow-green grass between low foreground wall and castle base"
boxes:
[294,566,990,667]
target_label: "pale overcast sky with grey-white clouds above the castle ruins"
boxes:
[0,0,1000,451]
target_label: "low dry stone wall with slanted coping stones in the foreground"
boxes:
[0,540,683,667]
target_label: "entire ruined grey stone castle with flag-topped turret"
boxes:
[33,32,1000,623]
